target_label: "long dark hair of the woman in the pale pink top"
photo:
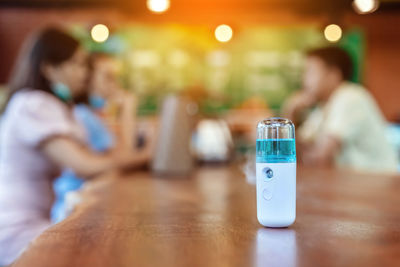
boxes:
[3,28,79,110]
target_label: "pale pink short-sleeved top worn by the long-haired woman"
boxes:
[0,90,85,265]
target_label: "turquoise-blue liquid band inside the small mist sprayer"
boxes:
[256,139,296,163]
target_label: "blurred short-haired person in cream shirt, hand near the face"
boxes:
[283,47,398,172]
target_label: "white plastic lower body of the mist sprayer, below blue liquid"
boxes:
[256,163,296,227]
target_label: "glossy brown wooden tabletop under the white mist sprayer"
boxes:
[10,167,400,267]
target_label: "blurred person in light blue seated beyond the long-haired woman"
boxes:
[51,53,143,222]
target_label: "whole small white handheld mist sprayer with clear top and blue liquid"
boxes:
[256,118,296,227]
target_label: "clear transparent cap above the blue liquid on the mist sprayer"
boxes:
[257,118,295,139]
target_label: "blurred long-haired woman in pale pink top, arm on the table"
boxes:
[0,28,149,265]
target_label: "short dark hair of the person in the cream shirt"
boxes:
[307,46,354,80]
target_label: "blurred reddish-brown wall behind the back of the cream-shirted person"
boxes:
[347,13,400,123]
